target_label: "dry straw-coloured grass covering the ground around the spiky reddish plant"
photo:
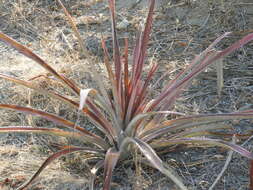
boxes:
[0,0,253,190]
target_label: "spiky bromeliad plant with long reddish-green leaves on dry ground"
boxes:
[0,0,253,190]
